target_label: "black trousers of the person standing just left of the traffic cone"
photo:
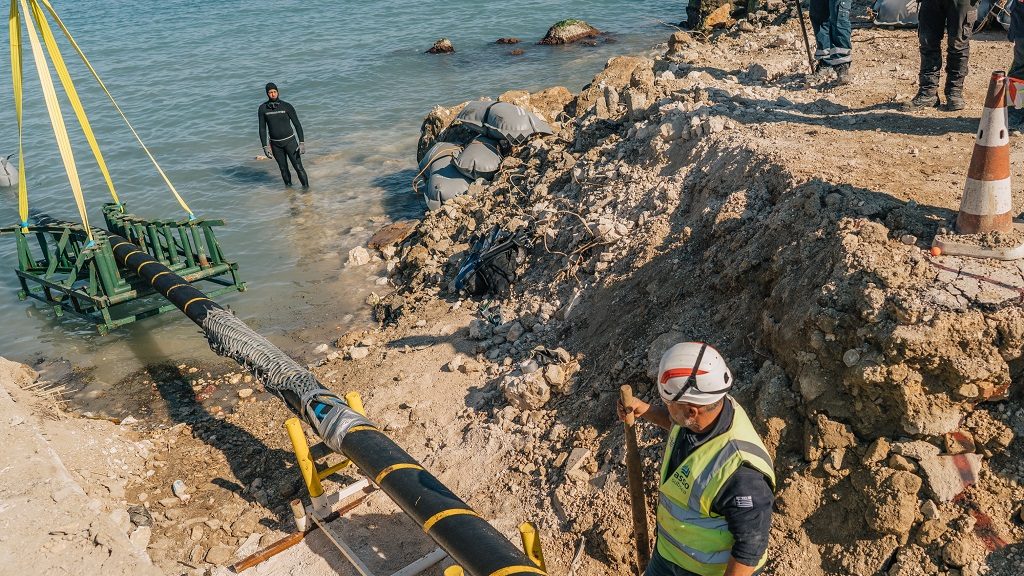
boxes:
[918,0,978,95]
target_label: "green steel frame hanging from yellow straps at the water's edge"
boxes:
[0,204,246,334]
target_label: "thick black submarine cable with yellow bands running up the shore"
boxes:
[109,235,546,576]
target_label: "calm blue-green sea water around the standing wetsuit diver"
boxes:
[0,0,685,381]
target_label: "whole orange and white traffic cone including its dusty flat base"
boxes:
[932,71,1024,260]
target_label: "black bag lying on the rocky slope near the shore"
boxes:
[455,227,529,296]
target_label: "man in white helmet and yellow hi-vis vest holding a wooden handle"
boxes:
[618,342,775,576]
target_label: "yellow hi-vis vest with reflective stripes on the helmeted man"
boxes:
[657,397,775,576]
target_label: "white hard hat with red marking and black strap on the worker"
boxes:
[657,342,732,406]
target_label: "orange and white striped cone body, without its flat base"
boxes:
[956,72,1014,234]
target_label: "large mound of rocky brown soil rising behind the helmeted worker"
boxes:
[372,22,1024,575]
